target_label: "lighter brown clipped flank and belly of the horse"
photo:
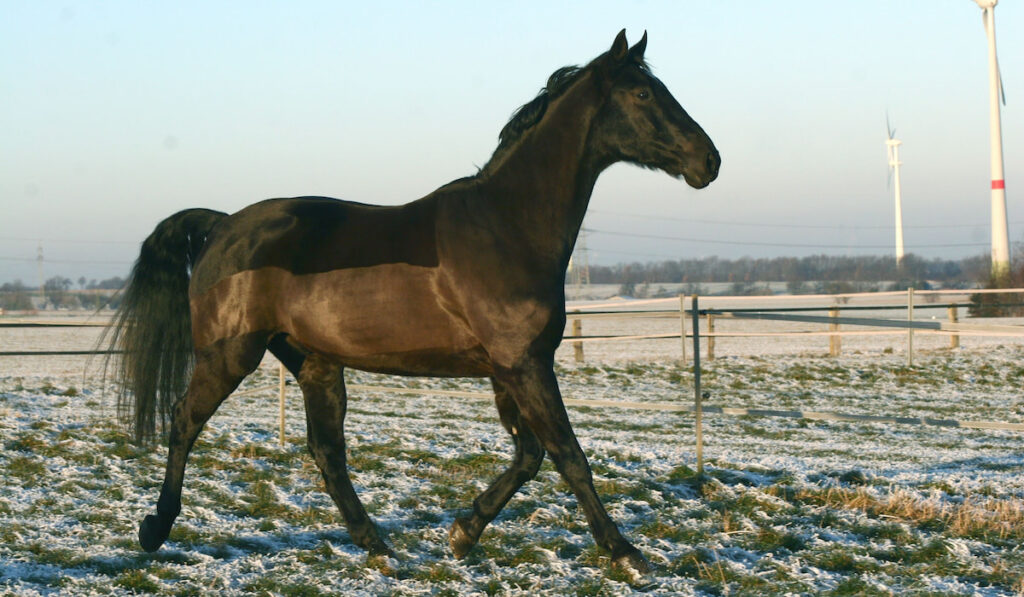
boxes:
[193,263,492,376]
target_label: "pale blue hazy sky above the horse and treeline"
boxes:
[0,0,1024,285]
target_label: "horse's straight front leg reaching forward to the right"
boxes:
[495,357,650,573]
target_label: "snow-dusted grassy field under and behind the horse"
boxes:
[0,314,1024,595]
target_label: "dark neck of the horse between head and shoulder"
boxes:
[486,80,604,266]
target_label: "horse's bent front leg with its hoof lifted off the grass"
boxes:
[449,379,544,558]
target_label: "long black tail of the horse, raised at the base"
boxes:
[100,209,227,443]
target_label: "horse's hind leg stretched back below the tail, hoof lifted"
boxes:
[138,336,266,552]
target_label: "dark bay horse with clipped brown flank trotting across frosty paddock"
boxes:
[110,31,720,572]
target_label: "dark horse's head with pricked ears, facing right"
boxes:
[591,30,722,188]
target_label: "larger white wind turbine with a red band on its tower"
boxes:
[974,0,1010,281]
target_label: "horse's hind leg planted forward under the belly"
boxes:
[299,355,394,556]
